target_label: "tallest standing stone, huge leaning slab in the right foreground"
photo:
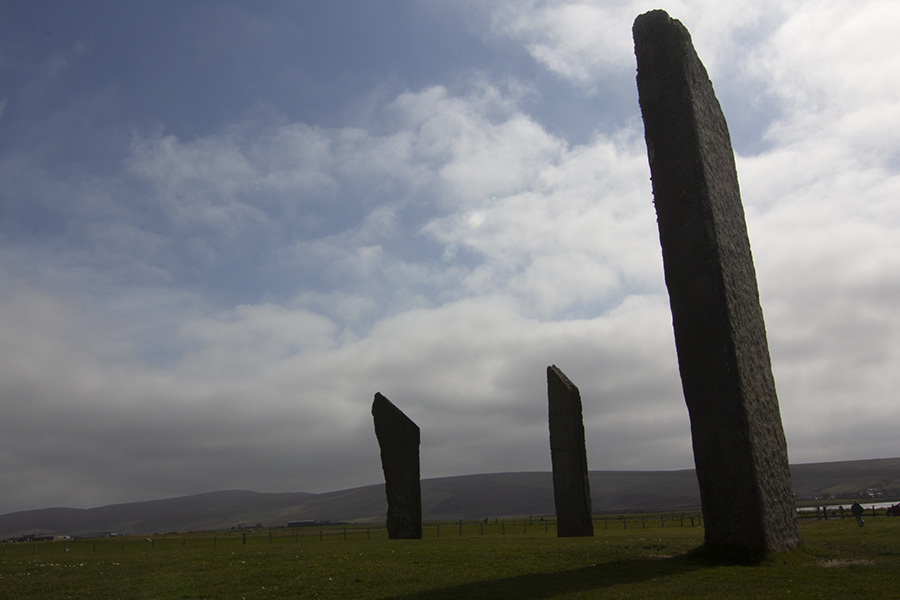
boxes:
[633,11,800,552]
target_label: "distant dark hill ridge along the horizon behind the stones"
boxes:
[0,458,900,538]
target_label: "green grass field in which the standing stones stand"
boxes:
[0,516,900,600]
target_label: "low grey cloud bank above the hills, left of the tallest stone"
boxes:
[0,272,690,509]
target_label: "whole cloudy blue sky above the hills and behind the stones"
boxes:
[0,0,900,513]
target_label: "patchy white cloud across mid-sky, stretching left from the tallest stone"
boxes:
[123,80,660,324]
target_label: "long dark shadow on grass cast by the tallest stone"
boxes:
[376,556,708,600]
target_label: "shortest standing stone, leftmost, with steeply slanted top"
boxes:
[372,394,422,540]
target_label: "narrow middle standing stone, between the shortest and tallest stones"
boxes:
[547,365,594,537]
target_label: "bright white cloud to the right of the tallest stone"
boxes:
[738,2,900,460]
